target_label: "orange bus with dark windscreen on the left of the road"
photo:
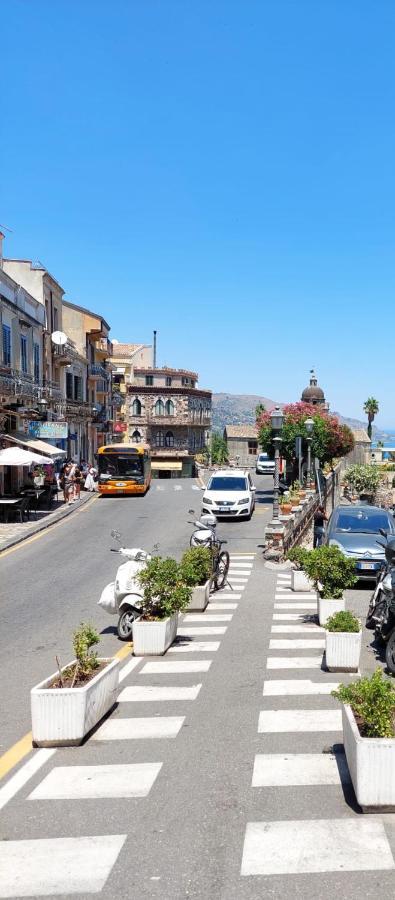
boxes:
[97,444,151,496]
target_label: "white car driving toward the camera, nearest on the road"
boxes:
[203,469,256,519]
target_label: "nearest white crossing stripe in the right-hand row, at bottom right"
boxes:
[241,818,395,875]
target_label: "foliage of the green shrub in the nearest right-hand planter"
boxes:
[332,669,395,737]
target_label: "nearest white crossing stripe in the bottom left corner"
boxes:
[0,834,127,898]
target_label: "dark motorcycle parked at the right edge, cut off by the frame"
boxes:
[366,529,395,674]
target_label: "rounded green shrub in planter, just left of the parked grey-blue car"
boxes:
[303,546,358,600]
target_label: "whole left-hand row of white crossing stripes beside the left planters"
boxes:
[0,554,254,898]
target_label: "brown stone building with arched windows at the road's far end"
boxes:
[127,367,211,478]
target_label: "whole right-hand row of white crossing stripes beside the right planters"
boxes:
[240,574,395,880]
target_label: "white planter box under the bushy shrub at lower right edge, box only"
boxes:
[342,706,395,812]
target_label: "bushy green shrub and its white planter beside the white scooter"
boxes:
[133,556,192,656]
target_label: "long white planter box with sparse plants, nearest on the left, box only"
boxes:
[30,659,120,747]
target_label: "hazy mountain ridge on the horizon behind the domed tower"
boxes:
[213,394,386,440]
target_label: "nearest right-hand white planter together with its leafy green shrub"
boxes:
[332,669,395,812]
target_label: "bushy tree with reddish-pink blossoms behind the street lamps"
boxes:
[257,402,354,464]
